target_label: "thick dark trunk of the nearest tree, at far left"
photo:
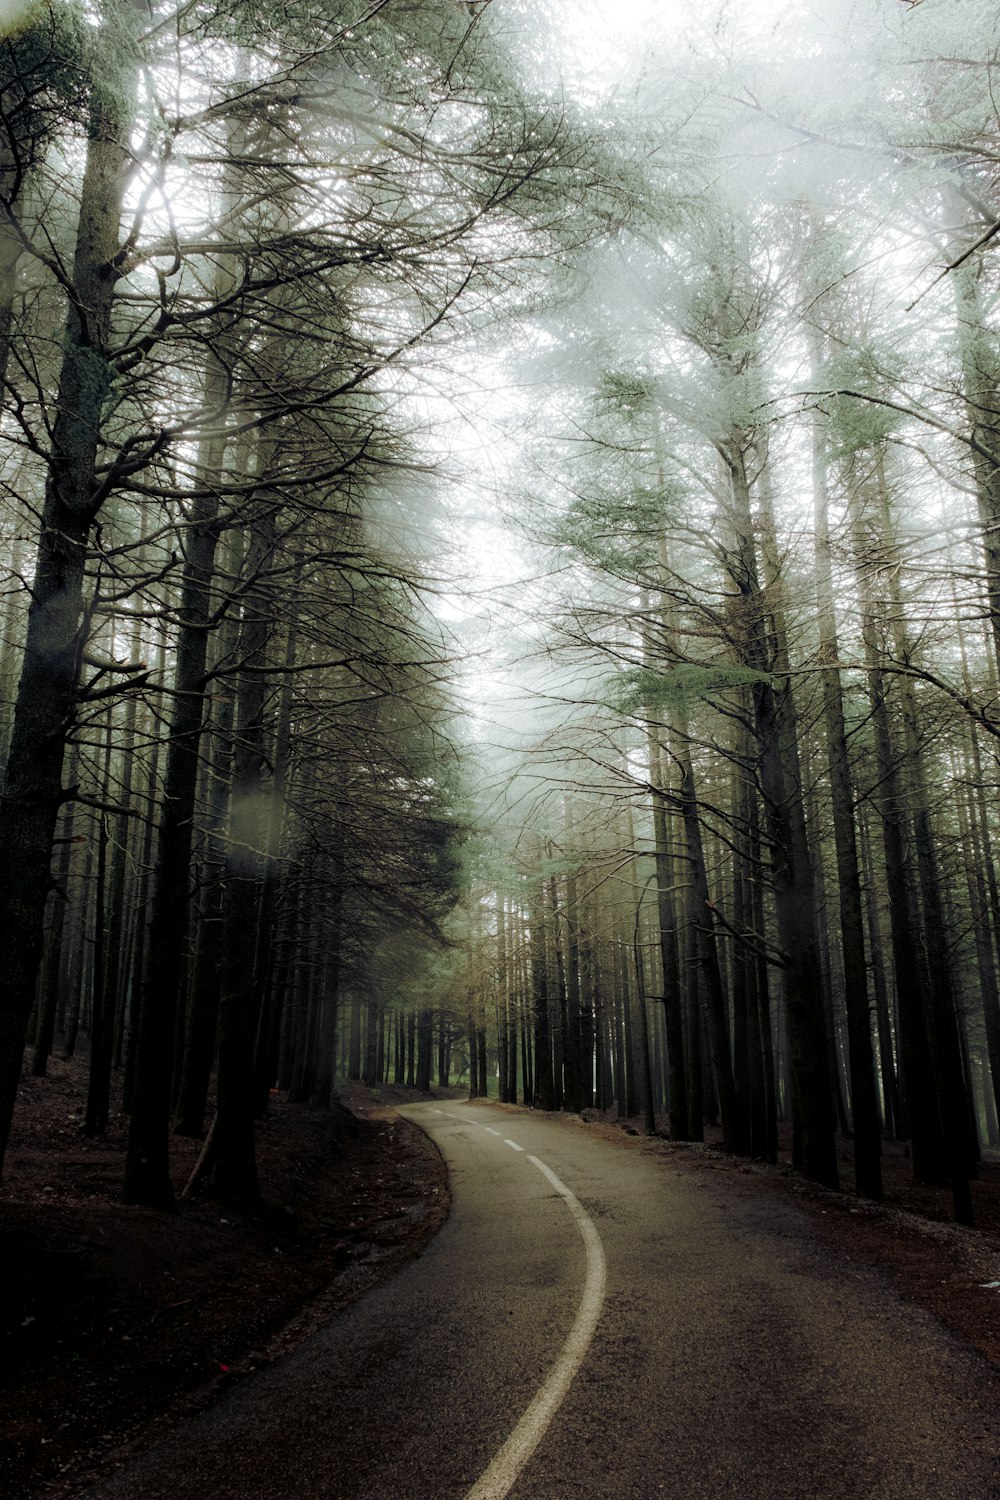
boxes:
[0,0,147,1167]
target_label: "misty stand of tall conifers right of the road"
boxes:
[443,6,1000,1220]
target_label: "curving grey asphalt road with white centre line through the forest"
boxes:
[76,1103,1000,1500]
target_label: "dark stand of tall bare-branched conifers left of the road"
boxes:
[0,0,614,1208]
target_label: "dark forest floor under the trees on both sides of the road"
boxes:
[0,1059,1000,1500]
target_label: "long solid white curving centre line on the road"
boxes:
[465,1140,607,1500]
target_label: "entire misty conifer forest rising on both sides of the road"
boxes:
[0,0,1000,1224]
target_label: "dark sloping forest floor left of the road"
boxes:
[0,1059,452,1500]
